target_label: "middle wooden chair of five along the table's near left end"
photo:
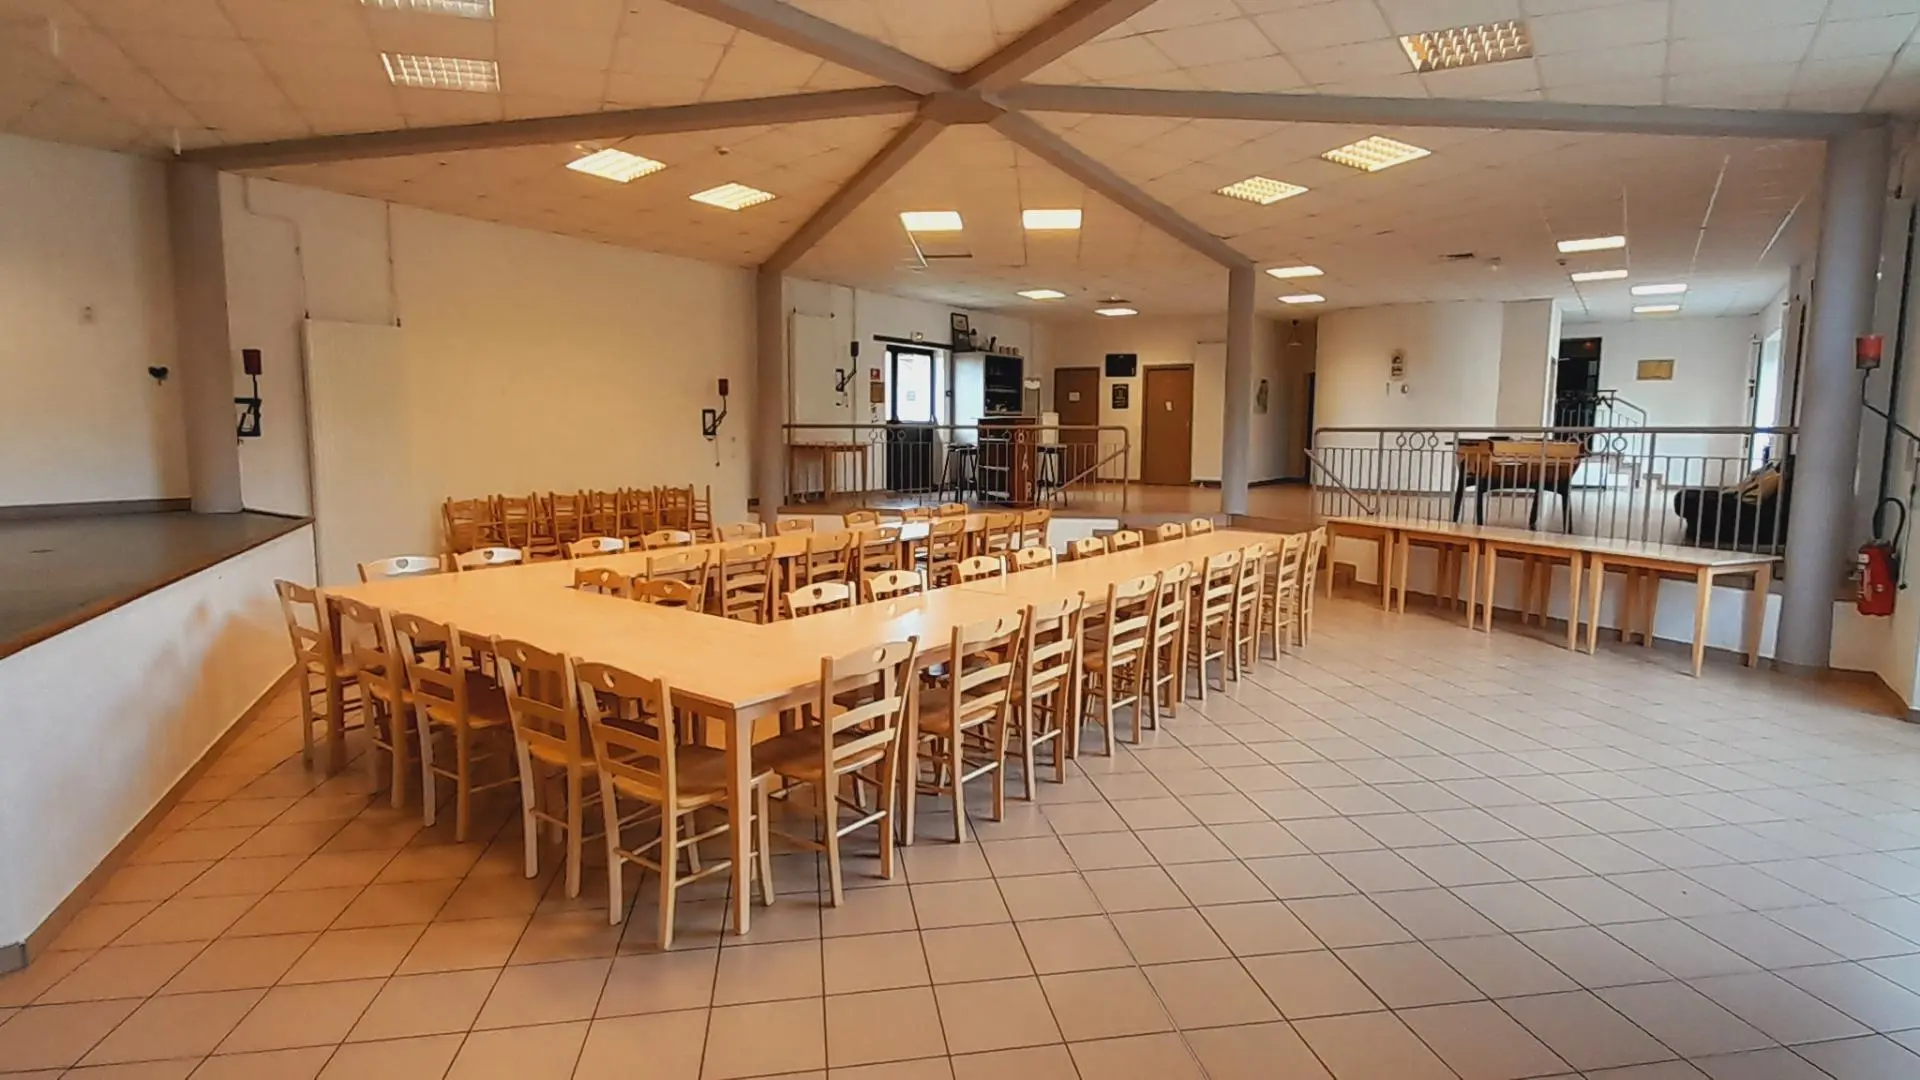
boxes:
[392,611,518,844]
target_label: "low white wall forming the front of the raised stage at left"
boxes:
[0,528,313,945]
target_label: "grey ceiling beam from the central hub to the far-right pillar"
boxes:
[998,83,1887,138]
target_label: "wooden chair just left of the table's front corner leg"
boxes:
[574,663,774,933]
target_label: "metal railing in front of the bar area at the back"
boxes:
[785,419,1133,511]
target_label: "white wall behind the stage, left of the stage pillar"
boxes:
[0,135,188,505]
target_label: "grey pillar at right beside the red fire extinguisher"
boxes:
[1776,127,1889,671]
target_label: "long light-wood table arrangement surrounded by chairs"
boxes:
[326,530,1271,934]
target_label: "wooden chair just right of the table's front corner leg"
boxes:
[753,638,920,907]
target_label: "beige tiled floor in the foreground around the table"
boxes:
[0,601,1920,1080]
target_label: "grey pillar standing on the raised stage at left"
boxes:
[167,163,242,513]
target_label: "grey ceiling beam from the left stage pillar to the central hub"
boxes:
[180,86,920,169]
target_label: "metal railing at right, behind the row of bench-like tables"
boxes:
[1308,427,1797,552]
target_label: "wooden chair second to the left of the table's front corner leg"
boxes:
[493,640,599,899]
